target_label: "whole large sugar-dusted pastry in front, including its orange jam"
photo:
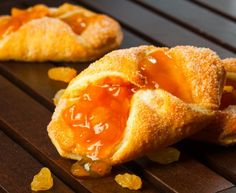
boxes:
[48,46,225,165]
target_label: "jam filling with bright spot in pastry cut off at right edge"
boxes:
[220,72,236,110]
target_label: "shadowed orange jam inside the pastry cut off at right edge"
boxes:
[220,73,236,110]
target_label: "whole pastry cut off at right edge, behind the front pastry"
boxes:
[193,58,236,145]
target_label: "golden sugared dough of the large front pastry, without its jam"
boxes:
[48,46,225,165]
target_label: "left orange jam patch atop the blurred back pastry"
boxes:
[0,5,49,37]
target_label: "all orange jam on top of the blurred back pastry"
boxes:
[0,5,91,38]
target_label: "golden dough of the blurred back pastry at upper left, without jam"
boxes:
[0,4,123,62]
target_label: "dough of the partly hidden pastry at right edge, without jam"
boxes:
[192,58,236,146]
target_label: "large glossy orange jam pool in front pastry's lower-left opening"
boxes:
[63,78,133,159]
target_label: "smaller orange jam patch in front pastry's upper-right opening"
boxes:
[140,50,192,102]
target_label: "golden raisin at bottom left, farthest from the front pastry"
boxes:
[31,167,53,191]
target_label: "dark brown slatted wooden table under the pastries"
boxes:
[0,0,236,193]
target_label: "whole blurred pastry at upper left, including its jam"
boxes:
[0,3,122,61]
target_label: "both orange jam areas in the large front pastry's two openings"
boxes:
[63,51,191,159]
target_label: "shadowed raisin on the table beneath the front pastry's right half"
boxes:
[147,147,180,164]
